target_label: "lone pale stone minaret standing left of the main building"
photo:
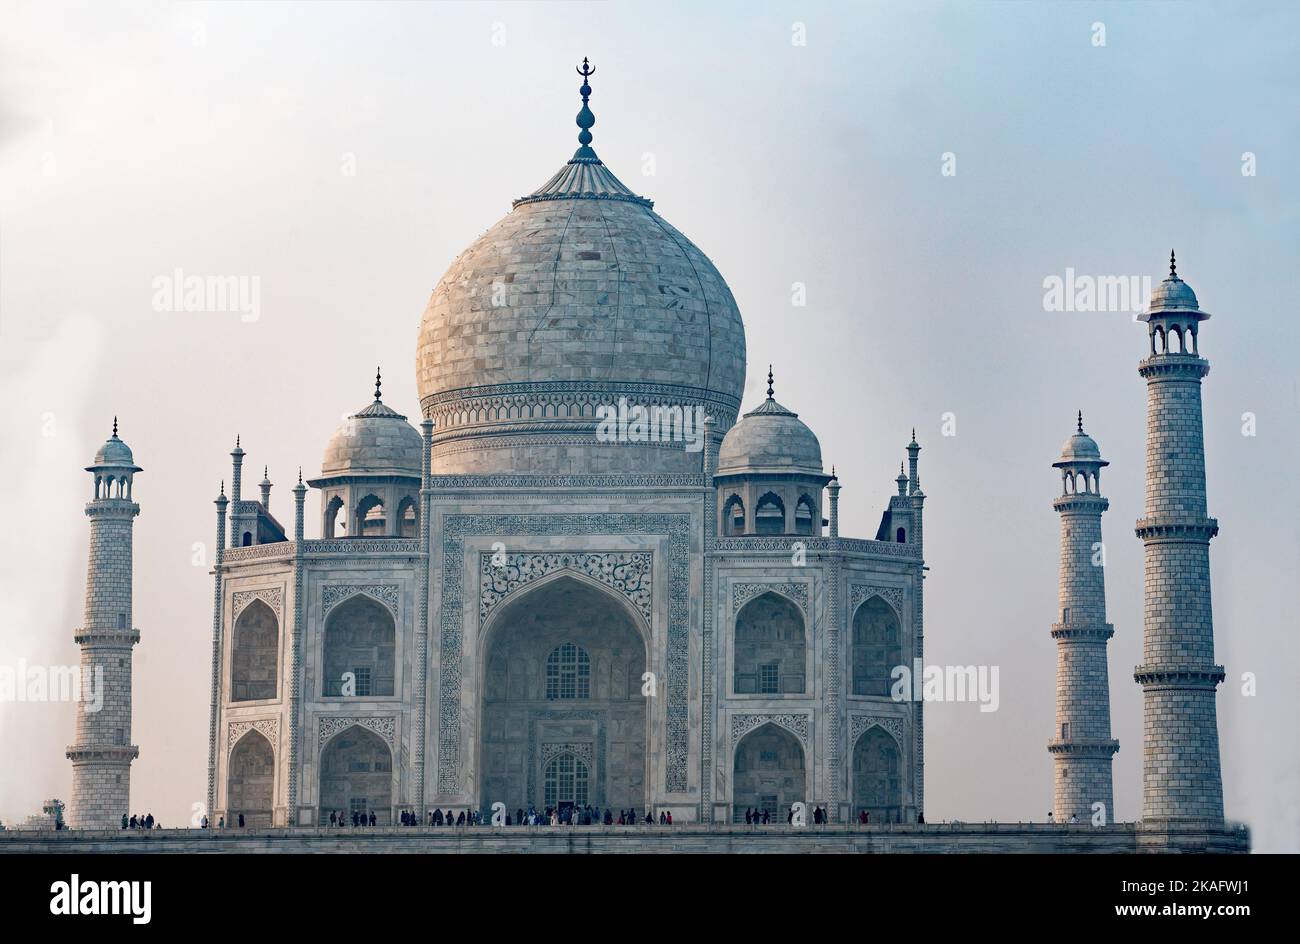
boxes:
[68,416,140,830]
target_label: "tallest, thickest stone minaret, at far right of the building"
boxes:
[1134,252,1223,824]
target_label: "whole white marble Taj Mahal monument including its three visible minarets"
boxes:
[38,61,1248,852]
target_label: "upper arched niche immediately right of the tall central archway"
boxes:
[735,593,807,694]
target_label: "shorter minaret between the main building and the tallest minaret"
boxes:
[1048,411,1119,824]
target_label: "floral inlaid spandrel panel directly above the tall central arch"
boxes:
[478,551,654,627]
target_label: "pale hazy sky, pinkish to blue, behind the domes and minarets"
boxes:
[0,3,1300,852]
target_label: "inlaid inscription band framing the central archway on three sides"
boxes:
[438,514,690,793]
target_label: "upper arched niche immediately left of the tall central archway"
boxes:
[322,594,397,698]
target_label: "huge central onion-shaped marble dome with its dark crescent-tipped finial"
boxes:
[416,60,745,473]
